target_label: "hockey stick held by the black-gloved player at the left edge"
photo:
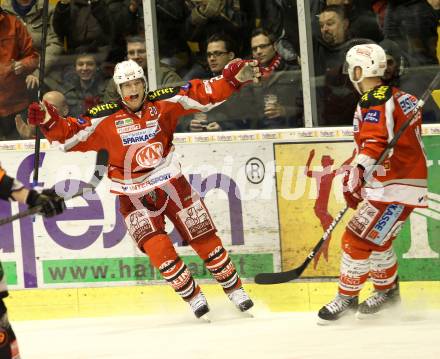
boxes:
[0,149,108,226]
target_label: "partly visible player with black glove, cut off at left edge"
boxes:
[0,167,66,359]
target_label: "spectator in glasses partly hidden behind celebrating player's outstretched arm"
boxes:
[178,34,245,132]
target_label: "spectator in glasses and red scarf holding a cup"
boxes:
[238,28,303,129]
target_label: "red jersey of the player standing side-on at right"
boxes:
[353,86,428,207]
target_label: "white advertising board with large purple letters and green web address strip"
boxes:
[0,141,280,289]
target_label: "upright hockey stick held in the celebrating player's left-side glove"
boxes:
[32,0,49,187]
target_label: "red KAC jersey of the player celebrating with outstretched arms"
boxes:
[42,76,236,195]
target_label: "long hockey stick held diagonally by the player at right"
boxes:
[254,72,440,284]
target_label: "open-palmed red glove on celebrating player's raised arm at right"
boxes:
[222,59,261,89]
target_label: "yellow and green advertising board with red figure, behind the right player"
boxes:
[275,136,440,280]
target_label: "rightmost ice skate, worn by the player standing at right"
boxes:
[356,280,401,319]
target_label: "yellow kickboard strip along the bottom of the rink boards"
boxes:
[6,282,440,320]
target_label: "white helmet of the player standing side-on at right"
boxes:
[344,44,387,93]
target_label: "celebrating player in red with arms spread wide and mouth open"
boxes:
[29,60,260,317]
